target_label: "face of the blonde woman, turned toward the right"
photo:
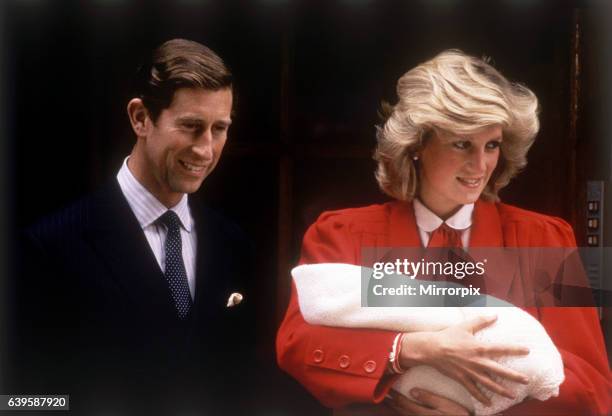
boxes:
[419,126,502,219]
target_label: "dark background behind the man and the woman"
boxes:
[0,0,612,412]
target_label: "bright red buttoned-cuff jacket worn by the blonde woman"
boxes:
[276,201,612,415]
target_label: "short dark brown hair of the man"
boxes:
[134,39,232,122]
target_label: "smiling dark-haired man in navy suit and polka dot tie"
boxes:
[11,39,254,414]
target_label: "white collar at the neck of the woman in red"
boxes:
[413,198,474,248]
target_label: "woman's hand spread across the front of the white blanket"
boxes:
[400,316,529,406]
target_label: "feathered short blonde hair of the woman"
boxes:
[374,49,540,201]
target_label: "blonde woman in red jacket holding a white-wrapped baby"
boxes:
[277,50,611,415]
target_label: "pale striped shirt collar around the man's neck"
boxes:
[117,156,193,232]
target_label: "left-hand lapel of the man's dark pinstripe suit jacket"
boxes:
[85,181,176,319]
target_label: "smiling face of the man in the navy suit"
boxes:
[129,88,232,207]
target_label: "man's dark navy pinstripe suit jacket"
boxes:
[10,180,254,410]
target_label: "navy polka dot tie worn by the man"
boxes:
[158,210,192,319]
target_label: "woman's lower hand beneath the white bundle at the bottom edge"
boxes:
[385,389,470,416]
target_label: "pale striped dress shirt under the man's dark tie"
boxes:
[117,157,197,299]
